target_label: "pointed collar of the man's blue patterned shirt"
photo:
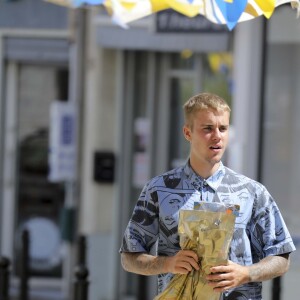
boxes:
[184,161,225,191]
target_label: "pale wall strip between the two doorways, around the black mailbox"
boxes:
[79,11,119,300]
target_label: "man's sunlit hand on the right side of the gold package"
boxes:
[206,261,250,292]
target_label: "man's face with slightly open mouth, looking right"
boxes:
[183,109,230,171]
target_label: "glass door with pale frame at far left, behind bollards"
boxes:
[1,62,68,296]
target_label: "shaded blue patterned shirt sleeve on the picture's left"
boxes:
[120,183,158,253]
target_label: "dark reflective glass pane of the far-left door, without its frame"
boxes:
[14,65,68,277]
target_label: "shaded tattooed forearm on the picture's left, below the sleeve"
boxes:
[121,253,167,275]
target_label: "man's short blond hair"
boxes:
[183,93,231,126]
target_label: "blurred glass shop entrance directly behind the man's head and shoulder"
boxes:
[119,51,232,300]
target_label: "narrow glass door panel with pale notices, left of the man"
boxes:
[118,52,156,300]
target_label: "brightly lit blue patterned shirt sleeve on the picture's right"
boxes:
[250,187,296,262]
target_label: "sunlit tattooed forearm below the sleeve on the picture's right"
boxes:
[249,254,289,282]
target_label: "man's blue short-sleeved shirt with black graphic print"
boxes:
[120,163,295,300]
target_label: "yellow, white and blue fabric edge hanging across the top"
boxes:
[48,0,300,30]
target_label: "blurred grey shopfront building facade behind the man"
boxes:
[0,0,300,300]
